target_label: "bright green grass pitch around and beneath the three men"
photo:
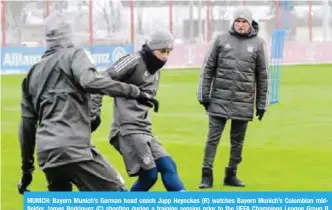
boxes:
[1,65,332,210]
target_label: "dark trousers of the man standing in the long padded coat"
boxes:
[203,115,248,169]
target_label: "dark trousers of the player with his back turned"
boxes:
[44,147,126,191]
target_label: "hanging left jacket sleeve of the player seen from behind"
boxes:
[19,79,38,173]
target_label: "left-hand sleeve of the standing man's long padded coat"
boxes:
[197,36,220,104]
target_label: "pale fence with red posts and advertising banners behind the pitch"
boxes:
[1,0,332,72]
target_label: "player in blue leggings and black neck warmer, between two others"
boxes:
[92,31,184,191]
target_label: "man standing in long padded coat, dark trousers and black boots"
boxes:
[198,7,269,188]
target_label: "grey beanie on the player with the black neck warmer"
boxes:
[146,31,174,50]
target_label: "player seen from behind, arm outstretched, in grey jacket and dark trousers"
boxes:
[18,13,157,193]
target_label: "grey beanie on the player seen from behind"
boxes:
[44,12,73,47]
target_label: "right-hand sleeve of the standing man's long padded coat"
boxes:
[256,40,269,110]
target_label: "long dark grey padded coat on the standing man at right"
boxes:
[197,21,269,121]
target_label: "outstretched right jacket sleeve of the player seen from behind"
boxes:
[71,49,140,99]
